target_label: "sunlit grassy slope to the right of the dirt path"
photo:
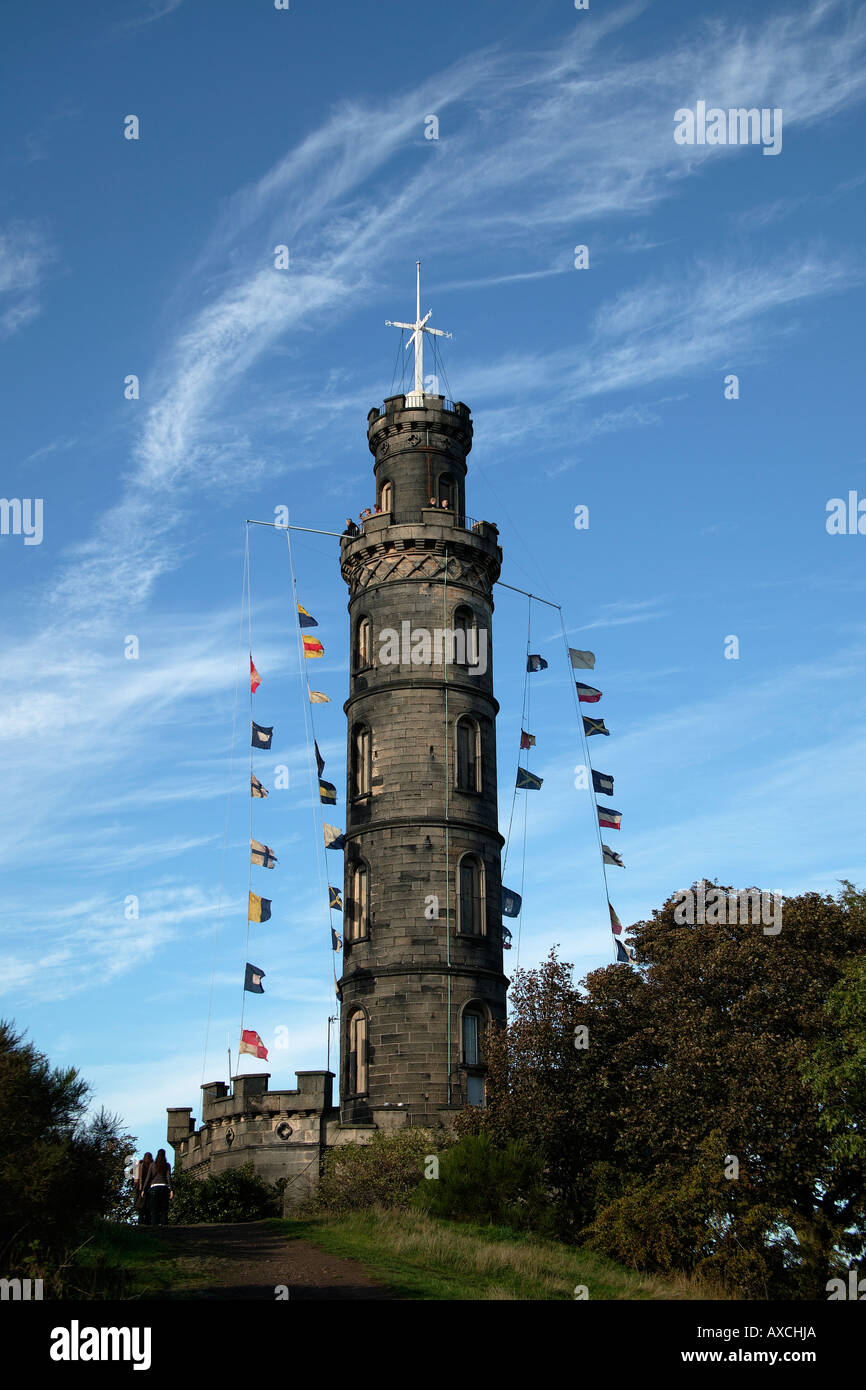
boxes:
[272,1207,726,1301]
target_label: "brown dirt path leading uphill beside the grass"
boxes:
[154,1222,398,1302]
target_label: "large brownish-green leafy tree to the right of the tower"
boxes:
[463,885,866,1298]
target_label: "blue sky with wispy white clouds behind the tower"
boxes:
[0,0,866,1148]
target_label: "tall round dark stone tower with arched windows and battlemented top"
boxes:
[339,386,507,1123]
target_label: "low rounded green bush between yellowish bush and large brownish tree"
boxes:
[414,1134,549,1230]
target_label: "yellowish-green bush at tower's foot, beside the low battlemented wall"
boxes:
[316,1129,442,1212]
